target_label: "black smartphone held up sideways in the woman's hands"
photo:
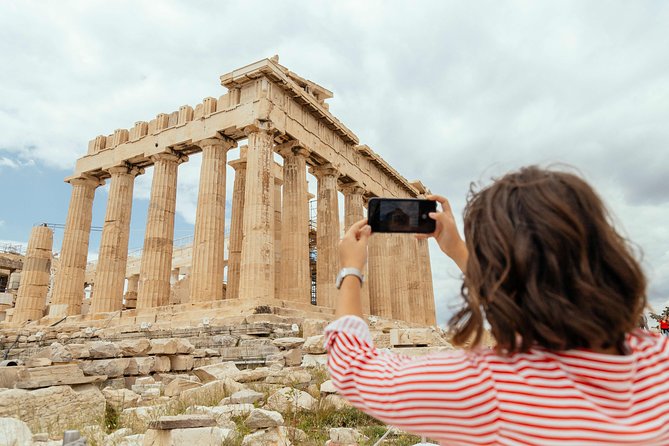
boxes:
[367,198,437,234]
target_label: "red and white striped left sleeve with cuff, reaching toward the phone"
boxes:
[325,316,498,444]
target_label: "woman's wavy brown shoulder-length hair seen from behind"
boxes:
[449,166,646,354]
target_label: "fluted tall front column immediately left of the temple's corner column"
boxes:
[190,138,235,303]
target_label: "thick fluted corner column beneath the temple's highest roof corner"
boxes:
[239,123,276,299]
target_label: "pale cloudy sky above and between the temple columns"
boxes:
[0,0,669,321]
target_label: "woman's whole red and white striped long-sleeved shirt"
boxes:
[325,316,669,446]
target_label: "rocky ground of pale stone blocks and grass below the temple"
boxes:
[0,318,452,446]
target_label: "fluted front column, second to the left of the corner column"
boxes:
[137,152,187,309]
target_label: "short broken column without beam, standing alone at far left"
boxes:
[12,226,53,323]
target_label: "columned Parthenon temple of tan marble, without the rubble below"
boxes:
[7,57,435,325]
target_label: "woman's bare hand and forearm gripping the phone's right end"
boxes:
[416,195,469,272]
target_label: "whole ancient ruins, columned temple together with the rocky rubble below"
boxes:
[0,57,444,446]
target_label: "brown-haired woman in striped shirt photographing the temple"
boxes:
[325,167,669,446]
